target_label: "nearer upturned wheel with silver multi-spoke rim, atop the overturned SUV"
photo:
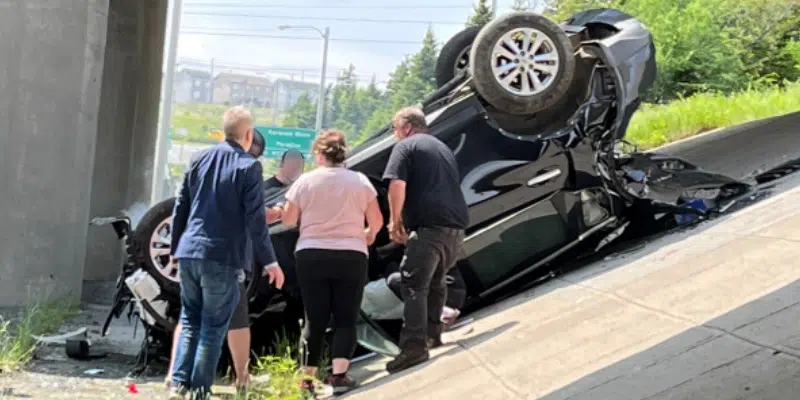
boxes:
[469,12,575,115]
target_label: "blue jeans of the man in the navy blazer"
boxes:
[172,259,239,394]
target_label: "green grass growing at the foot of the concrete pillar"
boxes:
[0,301,77,373]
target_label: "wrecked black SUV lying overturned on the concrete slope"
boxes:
[95,9,748,360]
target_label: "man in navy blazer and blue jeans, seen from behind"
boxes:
[170,107,284,399]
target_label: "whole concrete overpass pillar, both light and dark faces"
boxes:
[0,0,167,306]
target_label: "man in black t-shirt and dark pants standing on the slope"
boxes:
[383,108,469,373]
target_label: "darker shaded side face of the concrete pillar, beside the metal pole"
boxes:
[83,0,168,284]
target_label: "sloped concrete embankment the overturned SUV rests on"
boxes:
[348,114,800,400]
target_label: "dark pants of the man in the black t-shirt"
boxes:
[400,227,464,350]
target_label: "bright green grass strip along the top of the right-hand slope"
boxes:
[626,83,800,150]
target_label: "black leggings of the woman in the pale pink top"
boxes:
[295,249,367,367]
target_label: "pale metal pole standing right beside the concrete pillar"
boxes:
[150,0,182,205]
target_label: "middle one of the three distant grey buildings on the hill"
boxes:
[214,72,274,108]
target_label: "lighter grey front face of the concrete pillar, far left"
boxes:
[0,0,108,306]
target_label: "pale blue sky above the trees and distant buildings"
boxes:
[178,0,540,82]
